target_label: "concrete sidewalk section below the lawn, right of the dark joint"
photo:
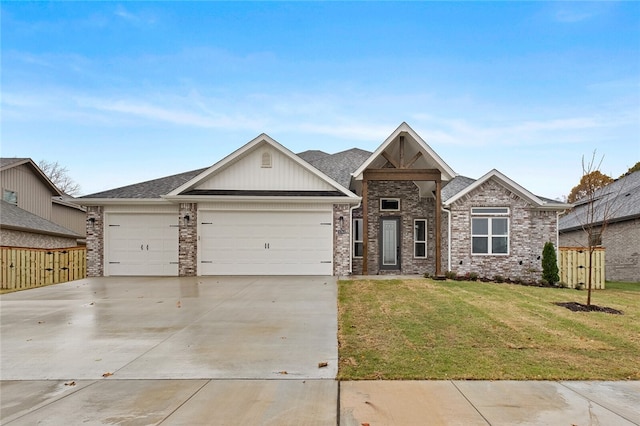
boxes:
[339,381,640,426]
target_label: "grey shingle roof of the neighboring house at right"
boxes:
[558,171,640,232]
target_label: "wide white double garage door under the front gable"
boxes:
[198,211,333,275]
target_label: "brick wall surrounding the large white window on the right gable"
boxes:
[444,180,557,281]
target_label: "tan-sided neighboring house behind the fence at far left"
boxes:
[0,158,86,248]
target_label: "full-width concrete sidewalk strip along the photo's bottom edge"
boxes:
[0,378,640,426]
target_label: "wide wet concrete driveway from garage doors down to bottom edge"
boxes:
[0,277,338,424]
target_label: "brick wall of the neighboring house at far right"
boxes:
[560,219,640,282]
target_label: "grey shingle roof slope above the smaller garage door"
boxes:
[77,168,207,199]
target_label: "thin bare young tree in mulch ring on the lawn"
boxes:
[573,151,622,306]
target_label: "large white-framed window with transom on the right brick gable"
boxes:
[471,207,509,254]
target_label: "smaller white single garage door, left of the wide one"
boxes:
[105,213,178,276]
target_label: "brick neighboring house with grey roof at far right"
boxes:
[559,171,640,282]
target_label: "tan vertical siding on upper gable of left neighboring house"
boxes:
[0,164,54,220]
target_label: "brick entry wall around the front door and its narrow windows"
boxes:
[353,181,438,275]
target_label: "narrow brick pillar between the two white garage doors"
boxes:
[178,203,198,277]
